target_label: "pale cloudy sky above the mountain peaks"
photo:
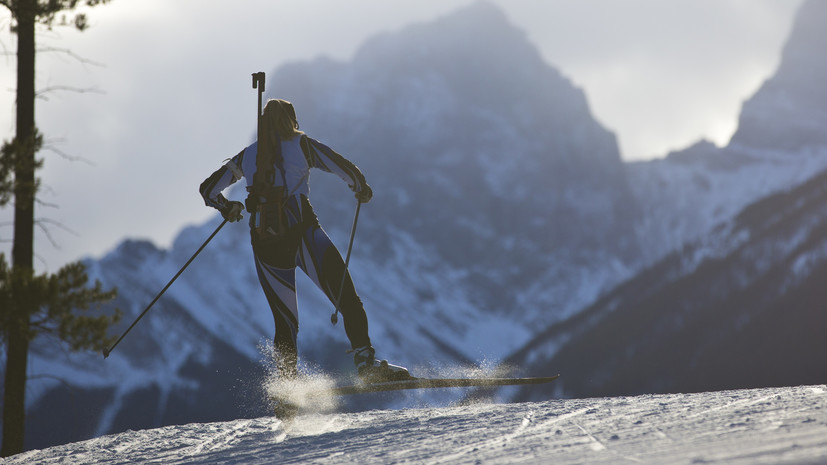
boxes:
[0,0,802,272]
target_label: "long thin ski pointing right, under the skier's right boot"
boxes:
[311,374,560,396]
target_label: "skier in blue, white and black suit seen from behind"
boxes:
[200,99,410,382]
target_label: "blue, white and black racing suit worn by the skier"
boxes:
[200,134,370,375]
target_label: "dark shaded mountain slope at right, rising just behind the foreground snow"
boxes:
[510,160,827,399]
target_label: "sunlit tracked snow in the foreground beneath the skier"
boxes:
[8,386,827,465]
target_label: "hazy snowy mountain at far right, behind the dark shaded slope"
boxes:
[628,1,827,260]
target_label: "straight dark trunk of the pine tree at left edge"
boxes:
[0,0,36,457]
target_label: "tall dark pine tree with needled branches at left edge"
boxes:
[0,0,119,457]
